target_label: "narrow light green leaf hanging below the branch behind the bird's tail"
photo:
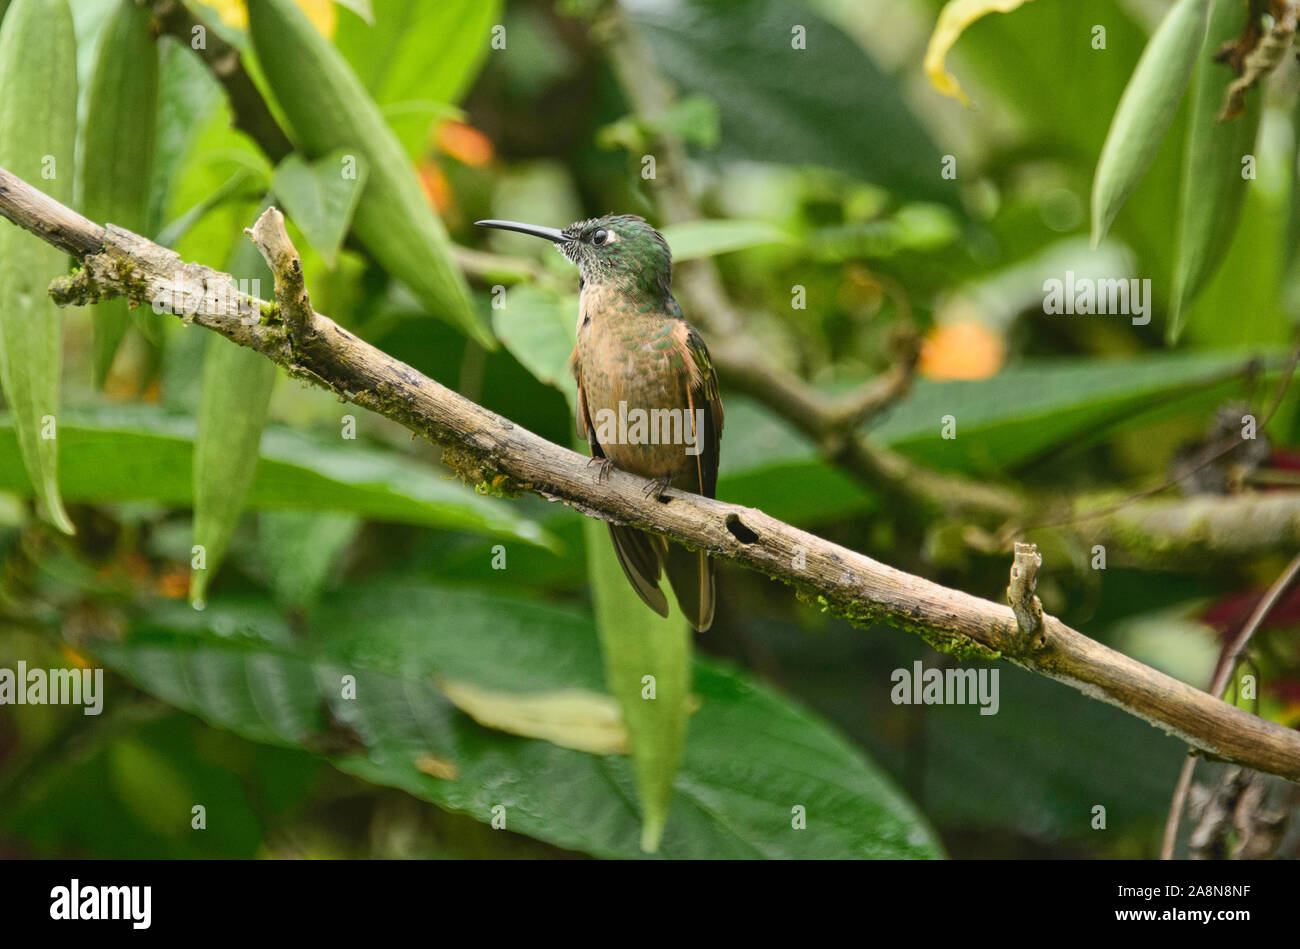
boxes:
[582,517,692,853]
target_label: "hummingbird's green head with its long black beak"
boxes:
[476,215,672,299]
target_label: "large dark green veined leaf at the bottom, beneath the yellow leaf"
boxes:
[91,586,939,858]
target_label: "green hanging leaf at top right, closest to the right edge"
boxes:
[1166,0,1262,343]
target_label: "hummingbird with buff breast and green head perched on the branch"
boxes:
[475,215,723,632]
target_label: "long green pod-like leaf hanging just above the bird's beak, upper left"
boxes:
[248,0,497,350]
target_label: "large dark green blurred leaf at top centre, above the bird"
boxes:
[629,0,956,204]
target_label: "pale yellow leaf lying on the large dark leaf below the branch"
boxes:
[436,679,628,754]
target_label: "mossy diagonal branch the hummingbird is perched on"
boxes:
[0,169,1300,780]
